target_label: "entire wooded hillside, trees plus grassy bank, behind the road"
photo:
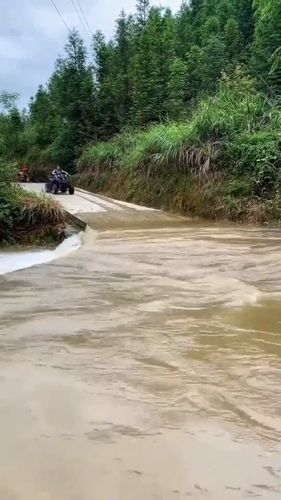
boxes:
[0,0,281,221]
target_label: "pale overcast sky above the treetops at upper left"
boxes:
[0,0,182,106]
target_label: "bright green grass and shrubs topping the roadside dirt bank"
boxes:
[79,68,281,206]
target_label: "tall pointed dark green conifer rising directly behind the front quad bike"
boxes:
[49,30,95,170]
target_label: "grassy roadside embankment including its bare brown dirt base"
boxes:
[75,70,281,223]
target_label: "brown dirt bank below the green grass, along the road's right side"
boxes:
[75,169,281,224]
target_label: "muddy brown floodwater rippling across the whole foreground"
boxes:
[0,223,281,500]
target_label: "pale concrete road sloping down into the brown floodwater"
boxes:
[24,183,183,230]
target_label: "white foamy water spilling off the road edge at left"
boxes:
[0,233,82,275]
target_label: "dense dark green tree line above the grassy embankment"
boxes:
[0,0,281,171]
